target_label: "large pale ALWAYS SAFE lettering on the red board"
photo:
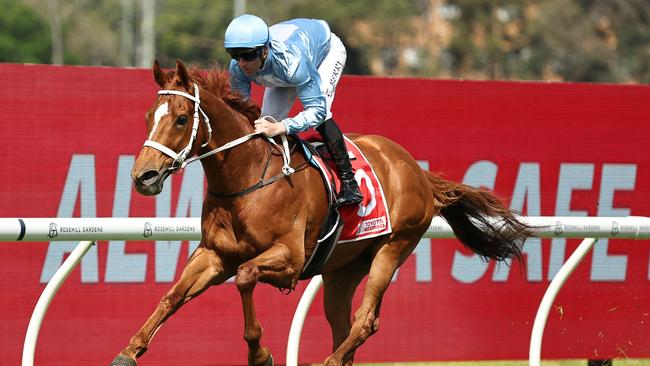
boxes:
[40,154,636,284]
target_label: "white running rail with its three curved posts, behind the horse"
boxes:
[0,216,650,366]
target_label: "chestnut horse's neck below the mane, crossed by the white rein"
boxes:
[201,99,268,193]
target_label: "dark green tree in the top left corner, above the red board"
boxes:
[0,0,50,63]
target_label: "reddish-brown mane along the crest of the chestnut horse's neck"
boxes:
[188,67,261,123]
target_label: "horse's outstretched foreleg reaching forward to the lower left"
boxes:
[111,247,228,366]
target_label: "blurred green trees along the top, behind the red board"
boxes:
[0,0,650,83]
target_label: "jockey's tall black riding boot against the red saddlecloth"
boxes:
[316,119,363,206]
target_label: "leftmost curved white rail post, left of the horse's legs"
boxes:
[22,241,95,366]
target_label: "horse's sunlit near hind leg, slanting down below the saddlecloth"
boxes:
[324,239,418,366]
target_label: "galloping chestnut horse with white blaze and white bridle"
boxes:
[111,60,532,366]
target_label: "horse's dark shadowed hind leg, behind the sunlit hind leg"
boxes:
[323,257,370,366]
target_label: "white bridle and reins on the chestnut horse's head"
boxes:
[143,83,295,176]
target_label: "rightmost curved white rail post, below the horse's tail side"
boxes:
[528,238,598,366]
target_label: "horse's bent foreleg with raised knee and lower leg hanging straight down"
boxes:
[235,244,297,366]
